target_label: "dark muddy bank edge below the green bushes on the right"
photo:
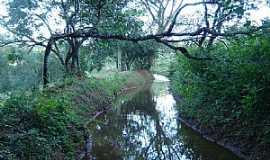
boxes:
[171,85,270,160]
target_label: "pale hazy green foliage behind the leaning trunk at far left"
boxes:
[0,46,63,93]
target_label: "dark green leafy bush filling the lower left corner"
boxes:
[0,92,81,159]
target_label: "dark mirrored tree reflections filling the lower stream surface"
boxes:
[89,84,239,160]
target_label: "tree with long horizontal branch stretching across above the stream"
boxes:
[2,0,266,85]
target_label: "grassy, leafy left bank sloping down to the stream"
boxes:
[0,72,146,160]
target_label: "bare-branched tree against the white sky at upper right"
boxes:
[141,0,260,47]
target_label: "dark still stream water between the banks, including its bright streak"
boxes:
[89,76,242,160]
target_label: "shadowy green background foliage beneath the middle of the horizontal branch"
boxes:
[81,40,158,72]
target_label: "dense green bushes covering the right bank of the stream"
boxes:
[171,35,270,160]
